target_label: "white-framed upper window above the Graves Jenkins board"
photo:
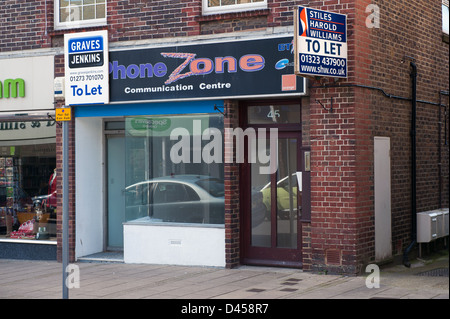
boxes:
[55,0,106,29]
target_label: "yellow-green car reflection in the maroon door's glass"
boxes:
[261,173,298,219]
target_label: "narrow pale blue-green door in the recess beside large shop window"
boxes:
[106,134,125,250]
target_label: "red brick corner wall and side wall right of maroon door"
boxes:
[310,1,448,273]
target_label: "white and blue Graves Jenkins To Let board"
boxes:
[64,31,109,105]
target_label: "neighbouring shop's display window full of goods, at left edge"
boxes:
[0,121,57,241]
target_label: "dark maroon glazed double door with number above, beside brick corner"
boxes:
[241,104,304,268]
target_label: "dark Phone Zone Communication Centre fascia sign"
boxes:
[109,37,306,102]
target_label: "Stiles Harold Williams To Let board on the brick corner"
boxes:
[294,7,347,78]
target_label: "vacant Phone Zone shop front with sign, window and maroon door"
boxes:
[69,35,308,267]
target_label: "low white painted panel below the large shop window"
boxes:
[124,222,225,267]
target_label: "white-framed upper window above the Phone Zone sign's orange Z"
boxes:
[203,0,267,15]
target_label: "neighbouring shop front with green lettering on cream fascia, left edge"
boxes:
[0,56,57,259]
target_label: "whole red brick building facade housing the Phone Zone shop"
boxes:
[0,0,449,274]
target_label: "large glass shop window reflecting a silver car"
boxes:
[125,114,224,224]
